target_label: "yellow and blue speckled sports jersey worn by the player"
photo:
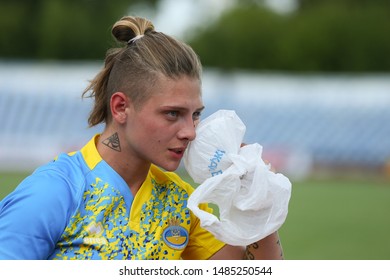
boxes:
[0,135,224,259]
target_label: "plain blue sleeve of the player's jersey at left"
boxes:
[0,169,75,260]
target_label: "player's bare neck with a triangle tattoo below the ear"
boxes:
[96,131,151,195]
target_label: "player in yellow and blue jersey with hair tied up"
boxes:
[0,17,282,259]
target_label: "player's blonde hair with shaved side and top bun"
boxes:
[82,16,202,126]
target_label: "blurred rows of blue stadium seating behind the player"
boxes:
[0,62,390,177]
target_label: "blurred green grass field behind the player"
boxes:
[0,170,390,260]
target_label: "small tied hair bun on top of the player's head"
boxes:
[111,16,154,43]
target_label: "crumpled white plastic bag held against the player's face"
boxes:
[184,110,291,246]
